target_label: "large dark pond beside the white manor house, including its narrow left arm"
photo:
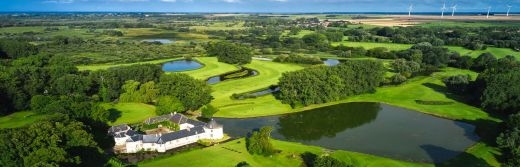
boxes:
[217,103,479,163]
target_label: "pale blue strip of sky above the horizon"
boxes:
[0,0,520,13]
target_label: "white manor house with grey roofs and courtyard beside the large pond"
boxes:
[108,113,224,153]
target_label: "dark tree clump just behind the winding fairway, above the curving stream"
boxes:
[206,41,253,64]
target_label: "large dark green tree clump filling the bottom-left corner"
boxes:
[0,115,106,166]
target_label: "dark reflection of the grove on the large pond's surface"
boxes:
[278,103,381,141]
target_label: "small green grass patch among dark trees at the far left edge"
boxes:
[0,111,47,129]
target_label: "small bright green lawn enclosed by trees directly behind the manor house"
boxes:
[103,103,156,125]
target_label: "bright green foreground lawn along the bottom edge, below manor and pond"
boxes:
[139,139,433,167]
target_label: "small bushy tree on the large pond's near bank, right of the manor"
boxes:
[246,126,275,156]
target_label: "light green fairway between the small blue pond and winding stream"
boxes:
[181,57,238,80]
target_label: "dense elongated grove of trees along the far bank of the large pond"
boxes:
[279,60,385,107]
